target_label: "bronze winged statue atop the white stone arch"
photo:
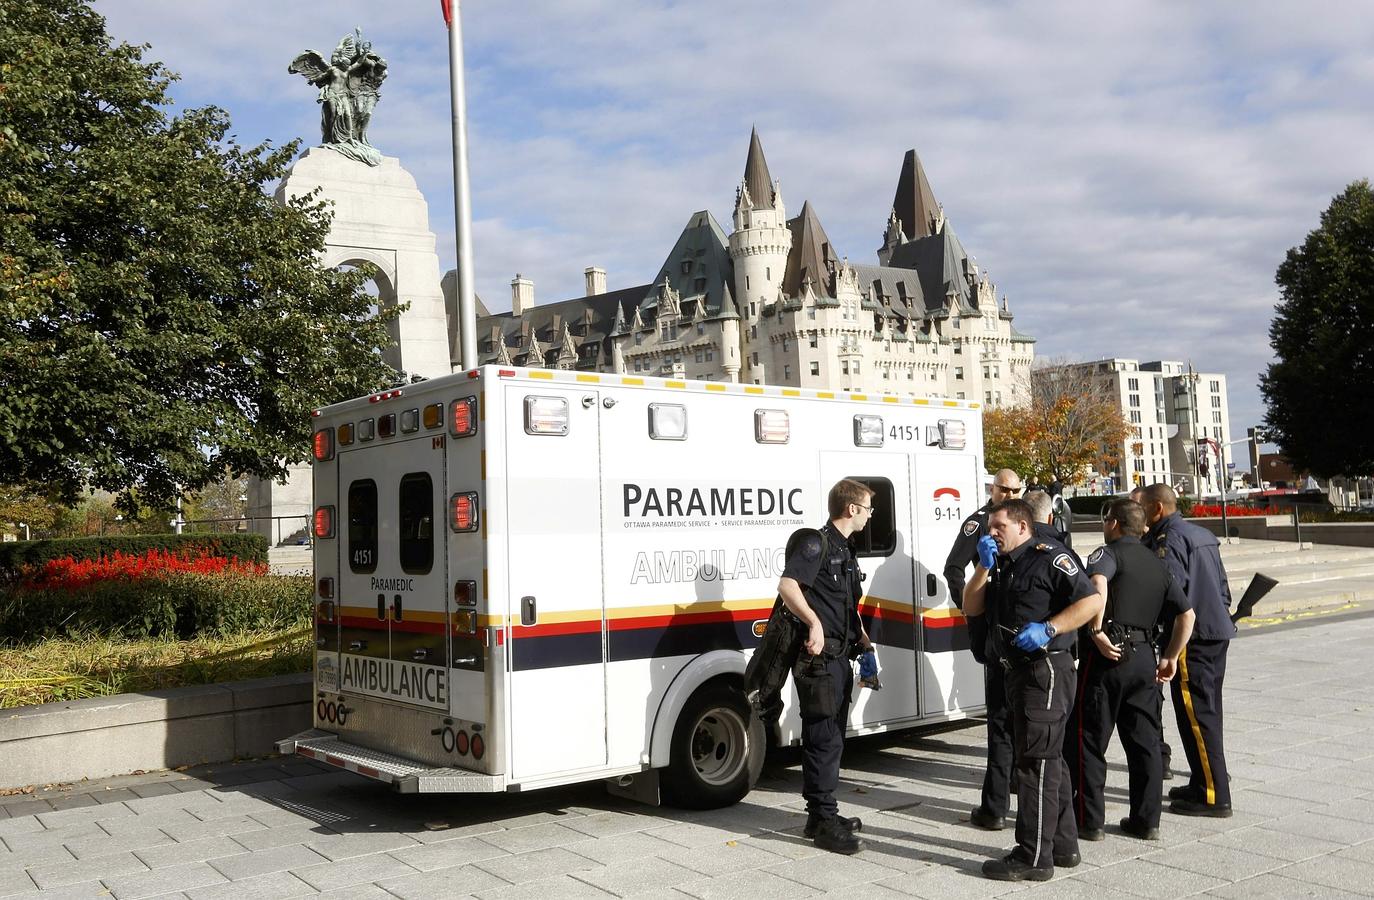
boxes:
[287,29,386,166]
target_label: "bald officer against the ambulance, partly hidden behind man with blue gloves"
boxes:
[944,469,1021,831]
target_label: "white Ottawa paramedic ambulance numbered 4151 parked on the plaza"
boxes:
[278,365,984,807]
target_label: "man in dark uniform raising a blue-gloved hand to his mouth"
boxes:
[963,500,1103,881]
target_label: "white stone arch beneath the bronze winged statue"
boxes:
[249,147,453,545]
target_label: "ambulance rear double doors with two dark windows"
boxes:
[339,425,448,710]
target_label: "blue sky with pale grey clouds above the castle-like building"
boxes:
[96,0,1374,450]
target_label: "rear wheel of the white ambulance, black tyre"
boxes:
[664,682,764,809]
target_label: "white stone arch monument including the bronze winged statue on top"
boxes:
[249,30,452,545]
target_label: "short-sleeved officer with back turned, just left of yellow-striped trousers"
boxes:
[1063,499,1193,841]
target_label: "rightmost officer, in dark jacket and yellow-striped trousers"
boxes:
[1140,484,1235,819]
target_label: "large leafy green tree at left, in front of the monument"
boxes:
[0,0,398,511]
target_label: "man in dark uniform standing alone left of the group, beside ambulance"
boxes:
[778,478,872,853]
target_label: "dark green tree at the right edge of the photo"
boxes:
[1260,180,1374,477]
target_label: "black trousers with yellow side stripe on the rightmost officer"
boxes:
[1169,640,1231,805]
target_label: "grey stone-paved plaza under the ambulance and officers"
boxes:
[0,611,1374,900]
